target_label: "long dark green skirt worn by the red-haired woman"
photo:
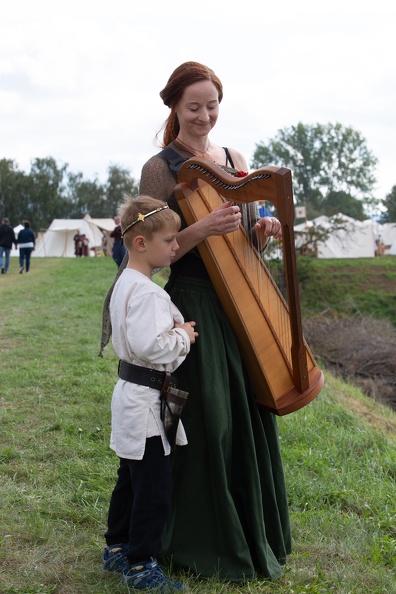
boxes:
[162,277,291,581]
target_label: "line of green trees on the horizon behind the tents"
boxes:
[0,122,396,230]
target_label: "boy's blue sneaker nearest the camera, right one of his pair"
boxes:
[121,558,184,594]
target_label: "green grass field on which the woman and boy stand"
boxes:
[0,258,396,594]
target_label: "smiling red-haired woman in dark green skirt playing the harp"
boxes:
[140,62,291,581]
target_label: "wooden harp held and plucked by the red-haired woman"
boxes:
[174,157,324,415]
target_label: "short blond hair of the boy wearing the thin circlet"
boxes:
[118,194,181,249]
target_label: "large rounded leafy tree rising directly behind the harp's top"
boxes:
[251,122,377,218]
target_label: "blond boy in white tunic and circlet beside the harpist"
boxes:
[103,196,198,592]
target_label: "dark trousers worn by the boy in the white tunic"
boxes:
[105,436,172,563]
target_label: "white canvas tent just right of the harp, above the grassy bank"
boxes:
[294,213,382,258]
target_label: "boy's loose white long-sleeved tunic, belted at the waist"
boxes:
[110,268,190,460]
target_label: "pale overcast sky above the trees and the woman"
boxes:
[0,0,396,198]
